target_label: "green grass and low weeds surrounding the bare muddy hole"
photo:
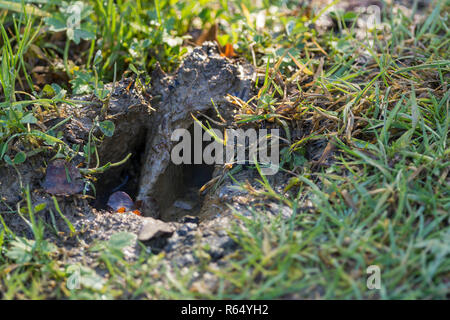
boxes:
[0,0,450,299]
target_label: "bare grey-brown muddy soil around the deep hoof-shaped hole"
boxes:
[0,43,264,265]
